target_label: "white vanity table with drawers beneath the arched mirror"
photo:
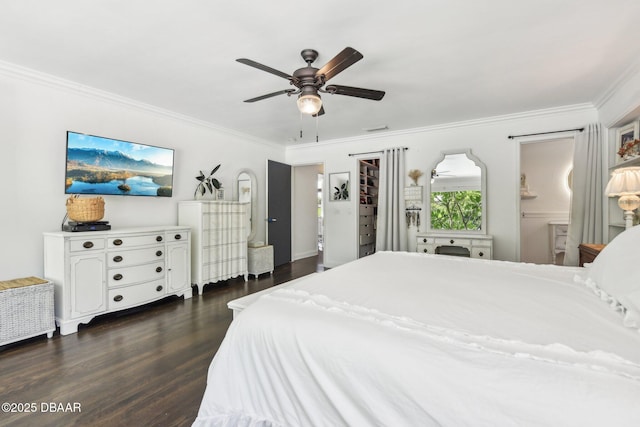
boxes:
[416,232,493,259]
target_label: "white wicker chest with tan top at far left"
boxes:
[0,277,56,345]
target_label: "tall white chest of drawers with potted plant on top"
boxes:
[178,200,248,294]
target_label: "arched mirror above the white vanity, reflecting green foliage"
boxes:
[427,150,487,234]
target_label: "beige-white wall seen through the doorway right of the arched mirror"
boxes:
[520,138,574,264]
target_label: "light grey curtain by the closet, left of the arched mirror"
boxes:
[376,148,407,251]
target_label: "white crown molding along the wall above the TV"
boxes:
[0,61,283,150]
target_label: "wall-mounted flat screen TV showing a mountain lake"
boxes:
[65,131,173,197]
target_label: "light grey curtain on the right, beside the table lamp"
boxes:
[564,124,604,265]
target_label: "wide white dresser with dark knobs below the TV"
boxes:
[44,226,192,335]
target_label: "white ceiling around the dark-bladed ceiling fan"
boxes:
[0,0,640,145]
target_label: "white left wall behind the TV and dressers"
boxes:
[0,68,284,280]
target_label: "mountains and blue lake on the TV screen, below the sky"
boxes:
[65,148,173,197]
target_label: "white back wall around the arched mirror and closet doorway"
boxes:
[286,105,597,267]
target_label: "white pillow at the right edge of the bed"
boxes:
[587,226,640,328]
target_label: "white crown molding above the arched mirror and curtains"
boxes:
[286,102,595,150]
